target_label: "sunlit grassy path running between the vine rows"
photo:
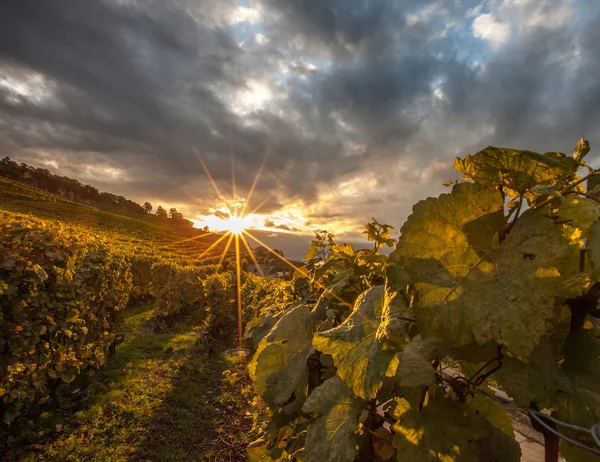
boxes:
[11,306,252,461]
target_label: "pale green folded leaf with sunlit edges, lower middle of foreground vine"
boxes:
[313,286,394,399]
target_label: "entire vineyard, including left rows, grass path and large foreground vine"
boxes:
[0,140,600,462]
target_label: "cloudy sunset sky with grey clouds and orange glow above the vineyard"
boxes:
[0,0,600,258]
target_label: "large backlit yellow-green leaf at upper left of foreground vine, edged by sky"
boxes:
[387,183,504,345]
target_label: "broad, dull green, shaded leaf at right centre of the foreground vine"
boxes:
[461,210,589,357]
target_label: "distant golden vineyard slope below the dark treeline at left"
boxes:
[0,177,239,260]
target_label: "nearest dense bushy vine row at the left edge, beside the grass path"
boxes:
[0,220,131,424]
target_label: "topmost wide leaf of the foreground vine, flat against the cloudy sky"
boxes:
[454,146,578,196]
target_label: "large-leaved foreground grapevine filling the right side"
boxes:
[249,140,600,462]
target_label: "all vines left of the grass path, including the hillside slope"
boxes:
[0,187,231,425]
